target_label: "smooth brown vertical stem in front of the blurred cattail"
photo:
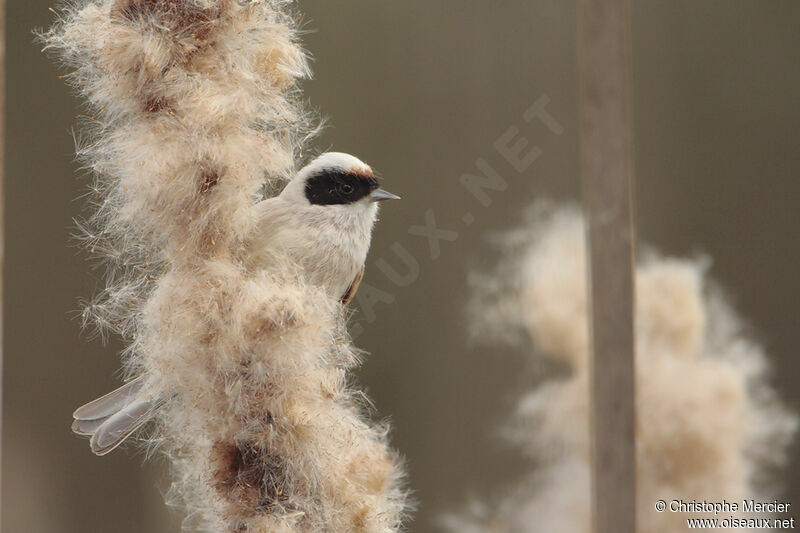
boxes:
[578,0,636,533]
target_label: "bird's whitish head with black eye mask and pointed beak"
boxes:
[281,152,400,213]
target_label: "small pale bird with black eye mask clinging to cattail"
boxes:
[72,152,400,455]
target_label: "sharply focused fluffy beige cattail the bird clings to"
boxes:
[42,0,404,532]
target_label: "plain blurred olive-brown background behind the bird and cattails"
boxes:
[2,0,800,533]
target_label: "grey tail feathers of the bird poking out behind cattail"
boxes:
[72,375,163,455]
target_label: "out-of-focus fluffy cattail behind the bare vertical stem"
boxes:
[445,204,797,533]
